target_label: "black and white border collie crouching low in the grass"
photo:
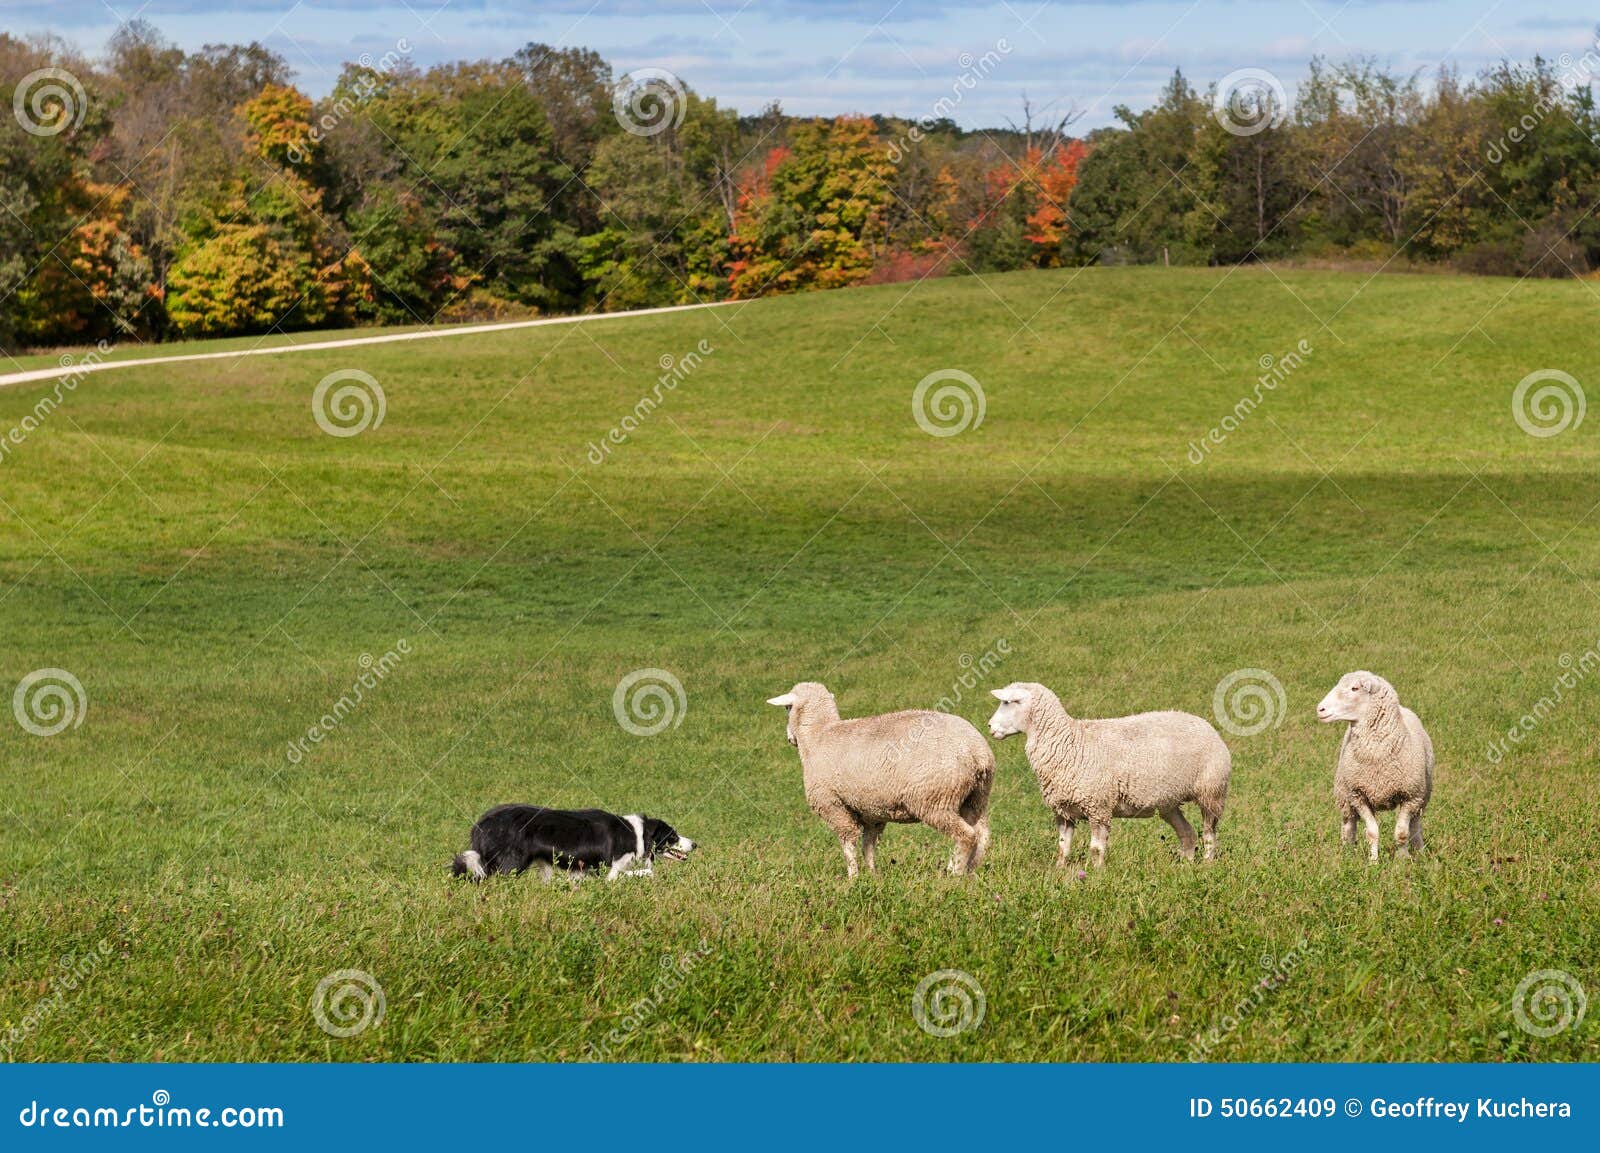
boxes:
[450,804,694,881]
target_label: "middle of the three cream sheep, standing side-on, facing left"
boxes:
[989,683,1234,868]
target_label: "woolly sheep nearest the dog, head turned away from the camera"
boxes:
[766,681,995,876]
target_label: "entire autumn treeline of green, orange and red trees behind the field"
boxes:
[0,22,1600,349]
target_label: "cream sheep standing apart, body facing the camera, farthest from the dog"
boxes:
[1317,670,1434,860]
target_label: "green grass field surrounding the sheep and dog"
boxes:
[0,269,1600,1060]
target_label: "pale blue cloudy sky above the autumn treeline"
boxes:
[9,0,1600,128]
